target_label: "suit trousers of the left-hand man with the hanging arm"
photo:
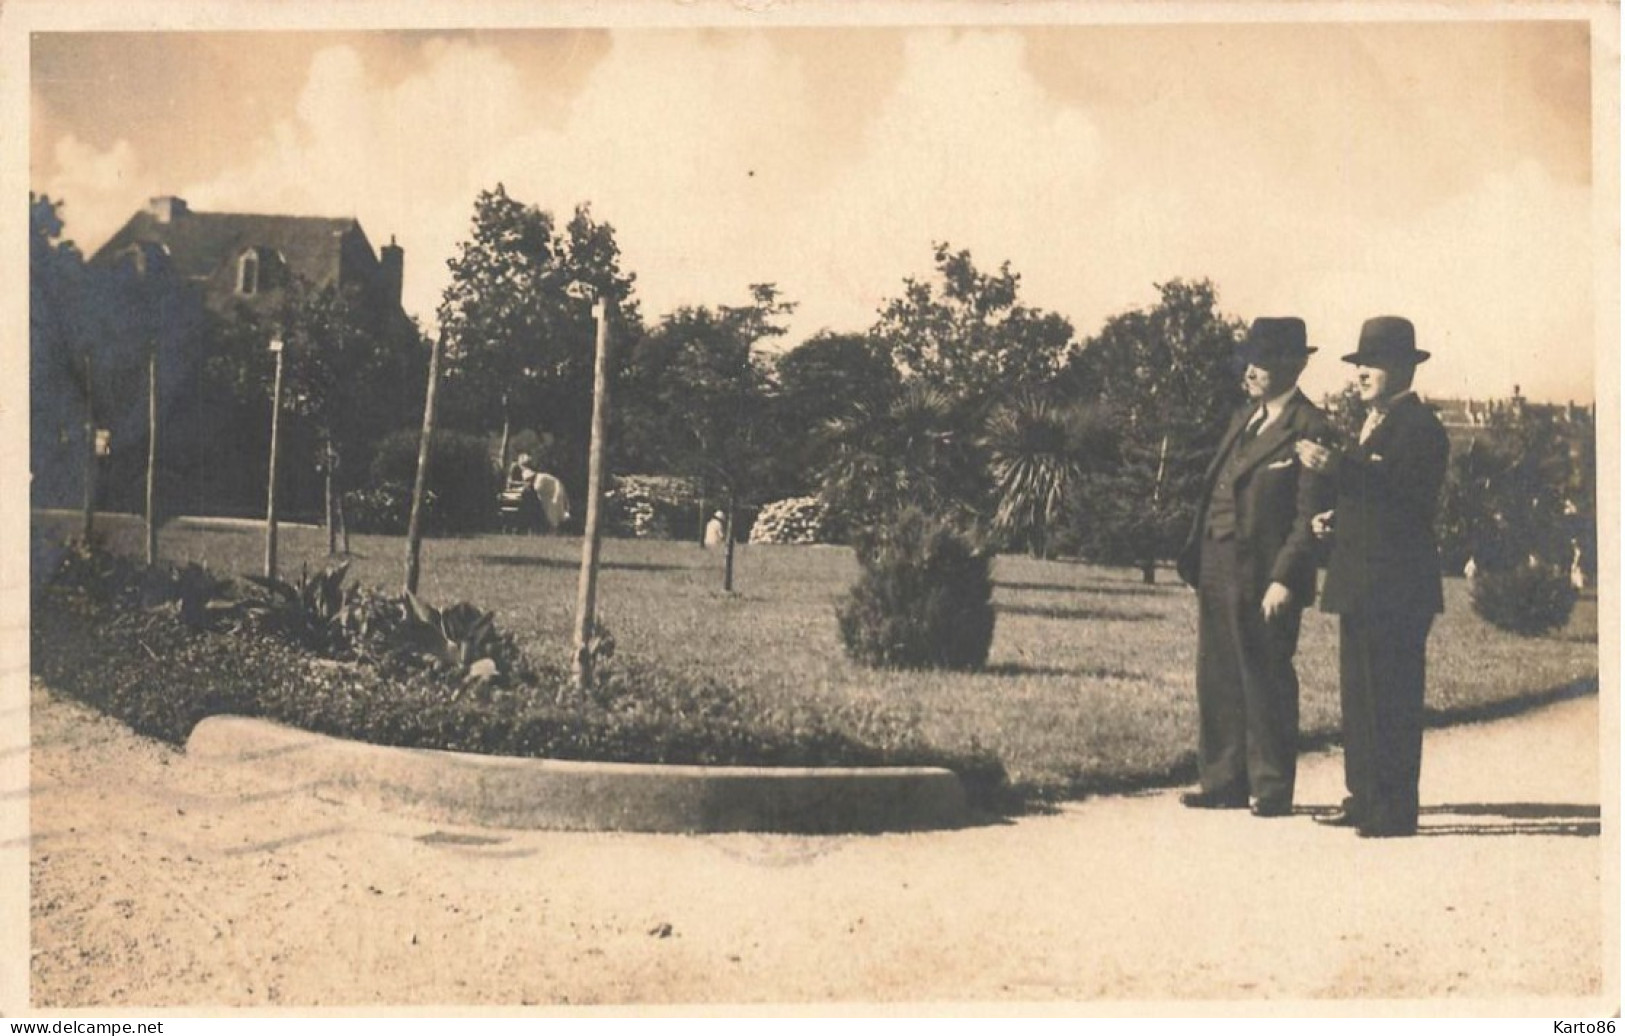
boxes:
[1196,539,1303,805]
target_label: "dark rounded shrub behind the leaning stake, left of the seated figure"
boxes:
[364,430,501,534]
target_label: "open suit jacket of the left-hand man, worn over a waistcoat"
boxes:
[1178,391,1333,607]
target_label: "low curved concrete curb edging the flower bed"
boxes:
[187,716,967,835]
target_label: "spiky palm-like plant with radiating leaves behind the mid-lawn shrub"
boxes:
[983,393,1115,557]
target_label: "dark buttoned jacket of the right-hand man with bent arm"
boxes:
[1321,396,1450,615]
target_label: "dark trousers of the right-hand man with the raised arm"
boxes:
[1337,612,1433,831]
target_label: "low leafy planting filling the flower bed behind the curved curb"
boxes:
[31,568,1003,804]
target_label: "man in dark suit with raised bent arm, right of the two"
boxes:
[1298,317,1450,838]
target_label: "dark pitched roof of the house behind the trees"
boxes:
[91,209,371,286]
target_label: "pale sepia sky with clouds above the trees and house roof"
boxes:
[29,21,1597,403]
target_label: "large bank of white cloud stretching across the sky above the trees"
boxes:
[46,29,1593,405]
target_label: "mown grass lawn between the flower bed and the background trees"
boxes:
[36,515,1599,799]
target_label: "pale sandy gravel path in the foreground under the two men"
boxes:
[15,685,1619,1017]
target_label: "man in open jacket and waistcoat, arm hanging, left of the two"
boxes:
[1180,317,1329,817]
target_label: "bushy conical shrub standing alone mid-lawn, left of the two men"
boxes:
[837,510,993,669]
